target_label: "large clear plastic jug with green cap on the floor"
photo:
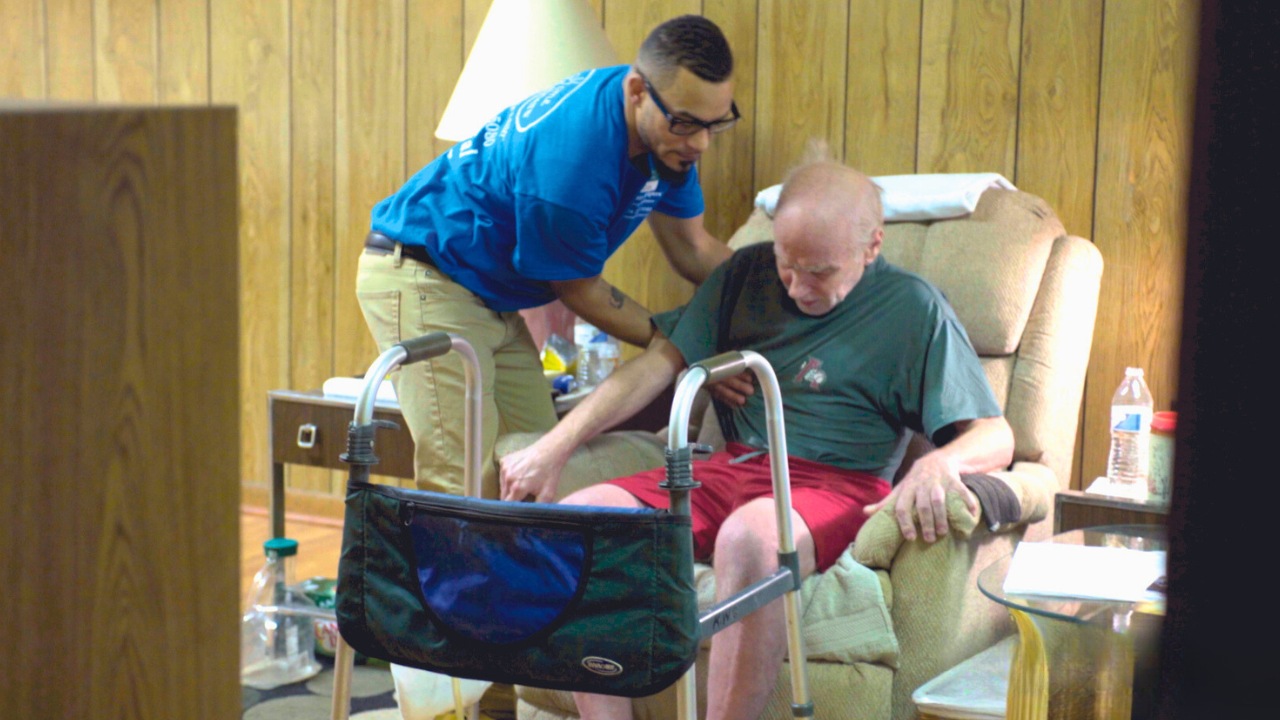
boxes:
[241,538,320,691]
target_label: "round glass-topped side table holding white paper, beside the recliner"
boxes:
[978,525,1167,720]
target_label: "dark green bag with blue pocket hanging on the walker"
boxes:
[337,482,699,697]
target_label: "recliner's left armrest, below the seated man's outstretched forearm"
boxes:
[494,430,666,500]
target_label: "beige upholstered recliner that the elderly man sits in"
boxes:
[498,190,1102,720]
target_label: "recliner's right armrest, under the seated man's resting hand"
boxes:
[854,462,1059,570]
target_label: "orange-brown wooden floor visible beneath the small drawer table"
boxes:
[241,506,342,611]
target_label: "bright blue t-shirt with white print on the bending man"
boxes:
[372,65,703,311]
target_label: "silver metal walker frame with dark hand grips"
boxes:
[332,333,814,720]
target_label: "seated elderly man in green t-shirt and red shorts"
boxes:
[502,161,1014,719]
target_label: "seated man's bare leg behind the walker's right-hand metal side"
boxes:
[707,498,815,720]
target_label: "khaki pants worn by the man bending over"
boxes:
[356,245,556,497]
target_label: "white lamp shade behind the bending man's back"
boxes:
[435,0,618,141]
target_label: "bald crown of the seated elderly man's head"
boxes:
[773,160,884,246]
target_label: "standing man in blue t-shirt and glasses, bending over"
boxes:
[356,15,739,496]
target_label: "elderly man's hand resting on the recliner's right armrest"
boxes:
[864,450,979,542]
